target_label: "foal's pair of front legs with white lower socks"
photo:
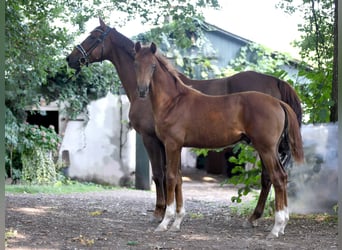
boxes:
[156,143,185,231]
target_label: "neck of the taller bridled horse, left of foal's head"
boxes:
[108,33,137,102]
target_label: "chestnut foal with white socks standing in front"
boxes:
[135,42,304,237]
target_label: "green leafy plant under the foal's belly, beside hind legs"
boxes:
[227,143,261,203]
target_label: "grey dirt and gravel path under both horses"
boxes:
[6,168,338,250]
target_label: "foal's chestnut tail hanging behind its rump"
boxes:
[281,103,304,163]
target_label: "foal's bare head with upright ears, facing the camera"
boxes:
[134,42,157,98]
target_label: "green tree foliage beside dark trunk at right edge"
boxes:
[278,0,338,123]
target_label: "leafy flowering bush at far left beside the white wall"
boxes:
[5,109,61,184]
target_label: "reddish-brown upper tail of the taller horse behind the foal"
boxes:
[277,79,303,127]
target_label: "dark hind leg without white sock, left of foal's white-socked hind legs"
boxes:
[248,166,272,226]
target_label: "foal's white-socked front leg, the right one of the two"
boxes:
[170,166,185,231]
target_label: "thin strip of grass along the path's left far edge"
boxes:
[5,181,118,194]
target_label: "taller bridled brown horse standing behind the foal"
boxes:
[67,19,302,223]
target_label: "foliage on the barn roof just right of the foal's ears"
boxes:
[136,17,220,79]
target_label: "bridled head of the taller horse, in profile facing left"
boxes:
[66,18,111,70]
